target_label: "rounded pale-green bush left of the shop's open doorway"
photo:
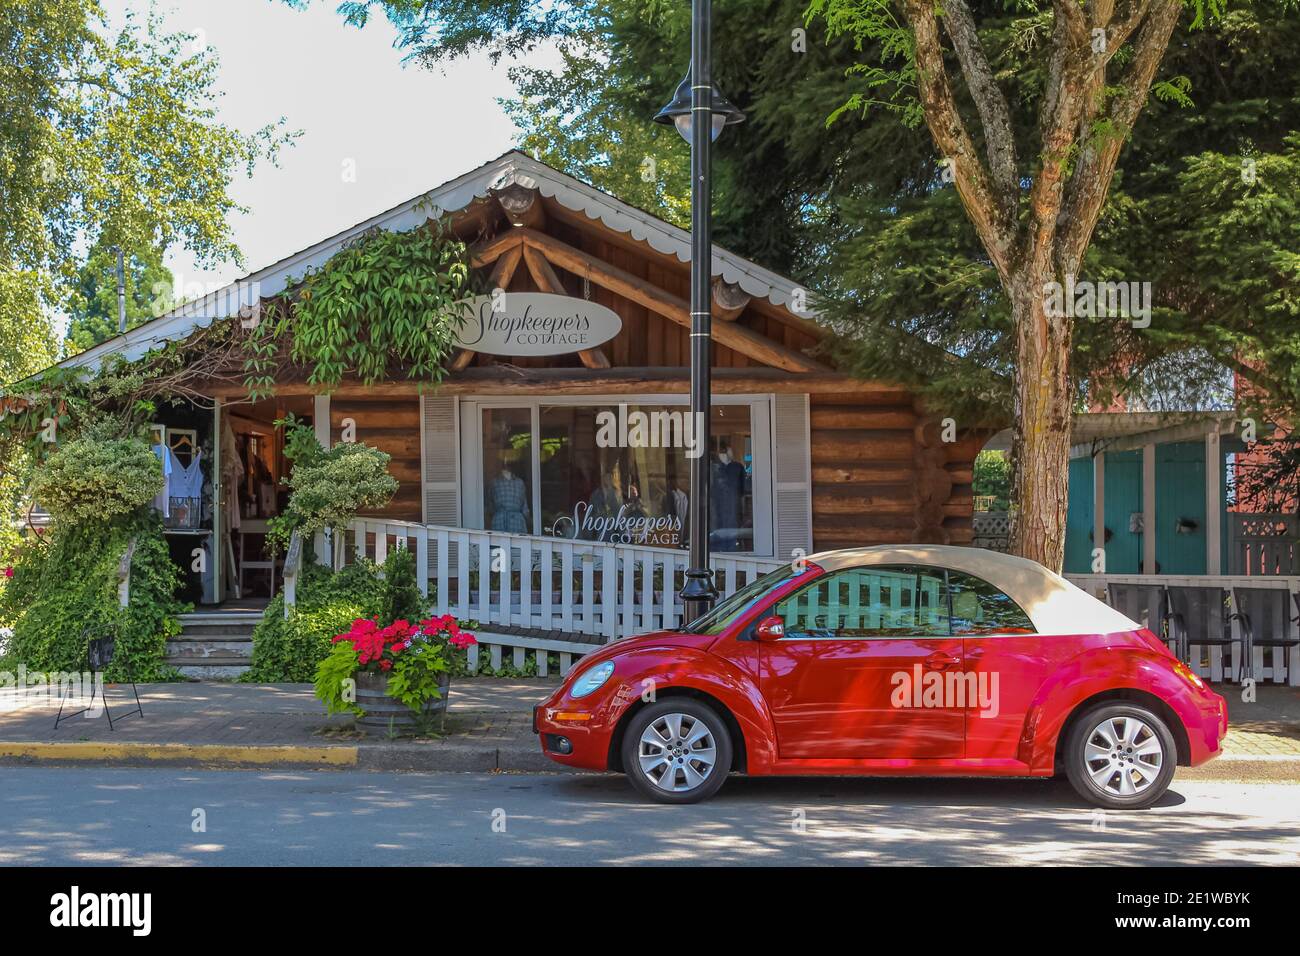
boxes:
[31,436,163,524]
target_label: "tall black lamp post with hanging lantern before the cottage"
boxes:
[655,0,745,620]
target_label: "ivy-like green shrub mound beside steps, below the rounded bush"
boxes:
[0,509,186,680]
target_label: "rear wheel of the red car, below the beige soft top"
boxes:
[1065,702,1178,810]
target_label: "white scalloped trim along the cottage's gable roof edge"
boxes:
[59,150,809,368]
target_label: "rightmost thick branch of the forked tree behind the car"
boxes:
[1057,0,1182,272]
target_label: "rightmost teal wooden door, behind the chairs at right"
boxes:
[1159,441,1205,575]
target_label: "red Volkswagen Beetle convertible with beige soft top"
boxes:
[533,546,1227,808]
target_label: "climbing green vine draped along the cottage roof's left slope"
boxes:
[0,220,486,460]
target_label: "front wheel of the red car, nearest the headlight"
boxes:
[623,697,732,804]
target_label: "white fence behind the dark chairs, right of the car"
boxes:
[1066,575,1300,687]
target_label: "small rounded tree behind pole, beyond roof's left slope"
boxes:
[65,245,172,352]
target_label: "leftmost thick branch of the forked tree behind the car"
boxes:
[902,0,1015,287]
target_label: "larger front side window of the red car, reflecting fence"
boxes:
[774,566,948,640]
